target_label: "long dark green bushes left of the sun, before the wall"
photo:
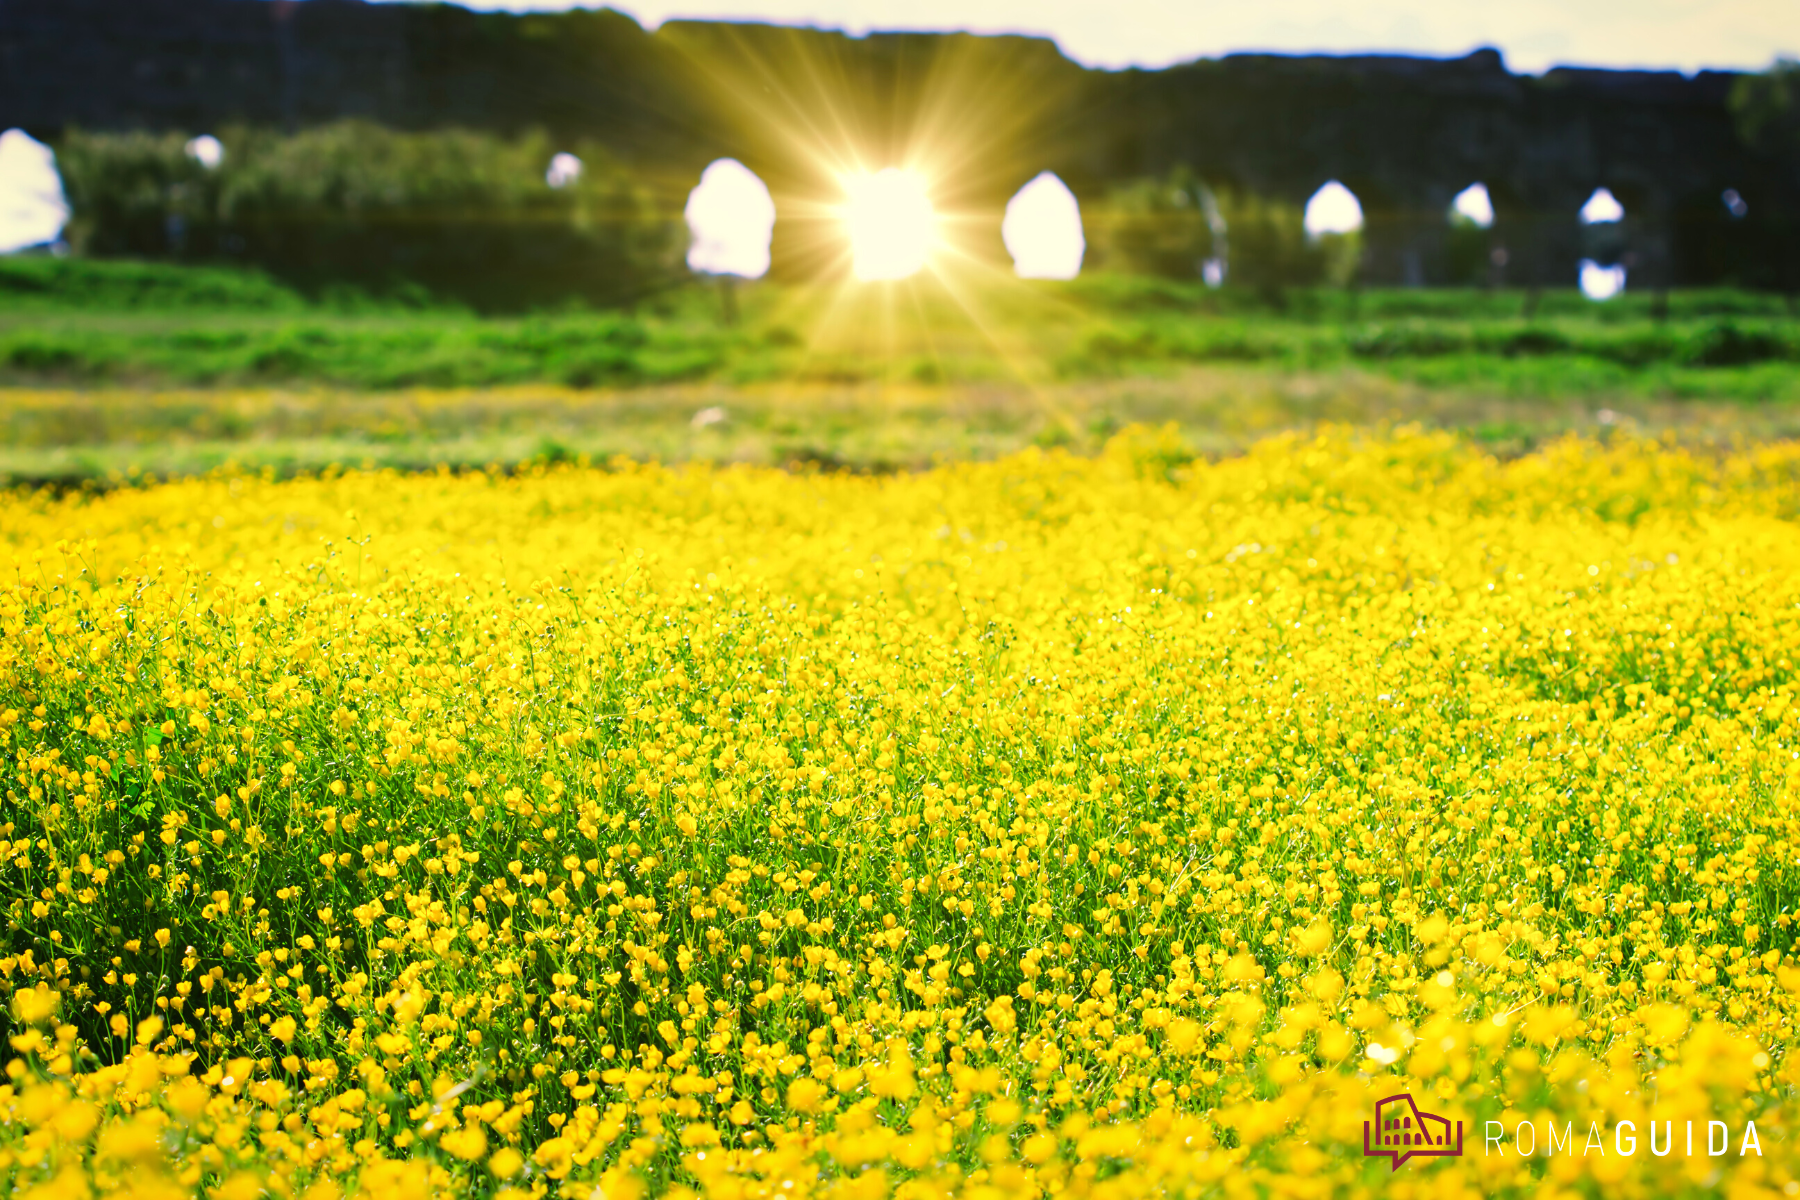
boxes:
[58,121,684,309]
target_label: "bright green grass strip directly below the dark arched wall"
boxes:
[0,259,1800,401]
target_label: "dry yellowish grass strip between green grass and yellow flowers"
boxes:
[17,365,1800,488]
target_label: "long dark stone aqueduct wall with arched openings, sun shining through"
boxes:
[0,0,1800,288]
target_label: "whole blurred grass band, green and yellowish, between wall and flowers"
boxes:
[0,257,1800,484]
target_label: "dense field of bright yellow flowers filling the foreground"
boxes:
[0,428,1800,1200]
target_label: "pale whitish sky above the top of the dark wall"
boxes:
[428,0,1800,74]
